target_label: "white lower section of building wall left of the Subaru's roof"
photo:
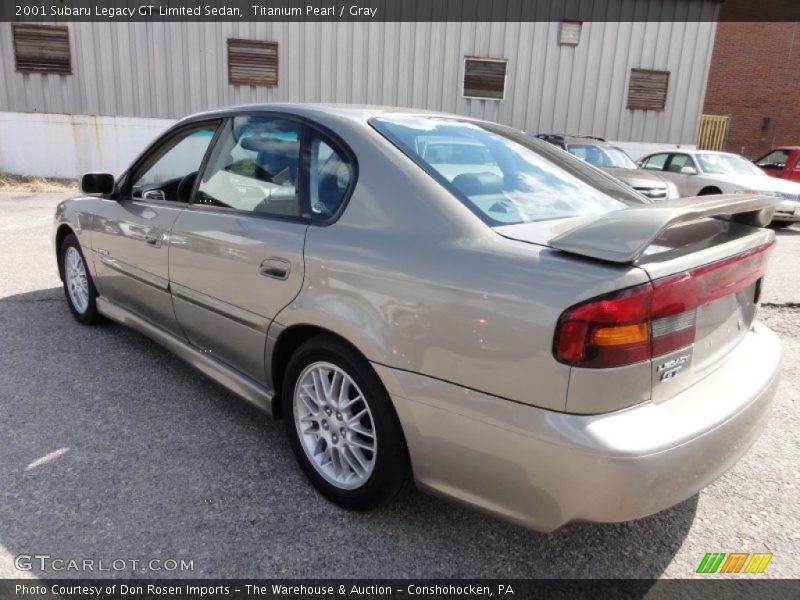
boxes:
[0,112,174,179]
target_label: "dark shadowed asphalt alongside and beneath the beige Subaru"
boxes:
[0,288,697,578]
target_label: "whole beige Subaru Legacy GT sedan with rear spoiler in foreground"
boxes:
[54,104,781,531]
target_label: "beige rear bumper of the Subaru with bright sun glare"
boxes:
[376,324,781,532]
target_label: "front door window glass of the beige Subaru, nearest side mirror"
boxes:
[131,123,217,202]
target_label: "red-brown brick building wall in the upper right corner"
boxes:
[703,17,800,159]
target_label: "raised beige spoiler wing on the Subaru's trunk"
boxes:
[548,194,779,263]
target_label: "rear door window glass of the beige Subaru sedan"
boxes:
[195,116,302,217]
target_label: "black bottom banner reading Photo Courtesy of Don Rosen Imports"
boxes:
[0,576,800,600]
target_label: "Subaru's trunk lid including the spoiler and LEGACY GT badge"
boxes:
[497,195,777,402]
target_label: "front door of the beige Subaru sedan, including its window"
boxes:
[92,122,219,337]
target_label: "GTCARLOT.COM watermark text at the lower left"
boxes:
[14,554,194,573]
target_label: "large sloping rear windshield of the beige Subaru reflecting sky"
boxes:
[370,116,645,226]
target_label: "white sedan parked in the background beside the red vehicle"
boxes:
[639,150,800,225]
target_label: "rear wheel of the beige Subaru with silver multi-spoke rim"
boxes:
[282,336,410,510]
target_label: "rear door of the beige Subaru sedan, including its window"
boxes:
[170,116,308,383]
